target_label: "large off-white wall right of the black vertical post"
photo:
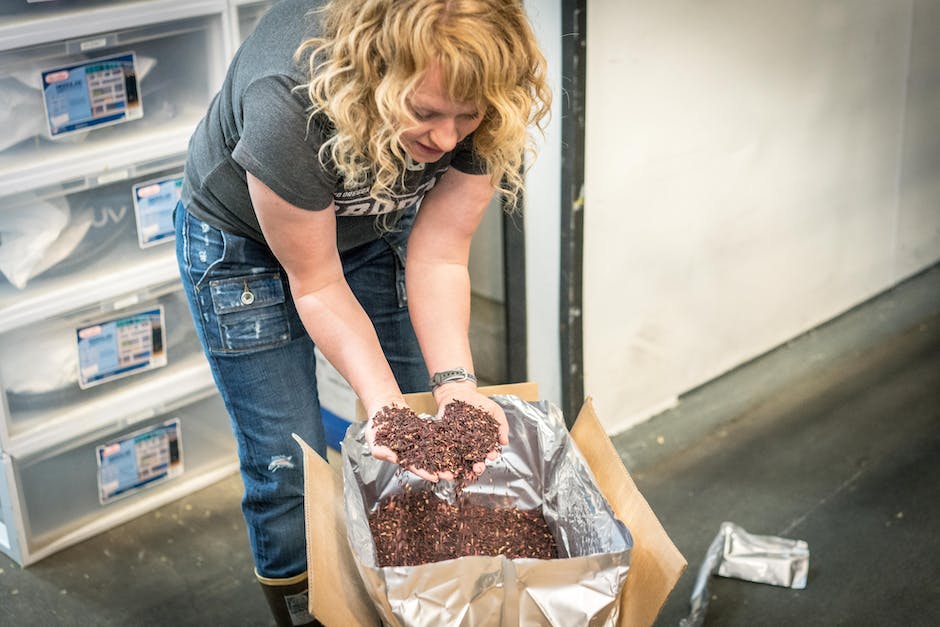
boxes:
[584,0,940,432]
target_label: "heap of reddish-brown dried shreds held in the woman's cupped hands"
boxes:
[373,401,499,486]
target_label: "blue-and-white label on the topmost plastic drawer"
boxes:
[42,52,144,139]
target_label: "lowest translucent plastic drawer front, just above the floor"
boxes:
[0,392,237,564]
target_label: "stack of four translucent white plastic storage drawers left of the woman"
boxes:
[0,0,236,564]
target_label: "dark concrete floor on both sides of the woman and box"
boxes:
[0,268,940,626]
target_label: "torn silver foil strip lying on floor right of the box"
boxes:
[679,522,809,627]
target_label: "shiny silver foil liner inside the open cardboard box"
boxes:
[342,395,633,627]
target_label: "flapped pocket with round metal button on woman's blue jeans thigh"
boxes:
[209,272,290,352]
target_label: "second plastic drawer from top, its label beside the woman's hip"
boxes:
[0,153,186,333]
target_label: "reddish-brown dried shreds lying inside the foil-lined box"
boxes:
[369,490,558,567]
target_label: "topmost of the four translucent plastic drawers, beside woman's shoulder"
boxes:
[0,15,224,193]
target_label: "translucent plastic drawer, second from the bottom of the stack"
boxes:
[0,281,211,452]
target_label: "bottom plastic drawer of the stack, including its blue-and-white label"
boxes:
[0,393,238,565]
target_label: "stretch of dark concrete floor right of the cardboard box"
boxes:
[615,268,940,626]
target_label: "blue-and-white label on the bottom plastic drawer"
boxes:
[96,418,183,505]
